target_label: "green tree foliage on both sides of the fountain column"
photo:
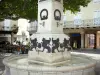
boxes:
[0,0,91,21]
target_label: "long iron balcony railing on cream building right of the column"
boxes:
[64,18,100,28]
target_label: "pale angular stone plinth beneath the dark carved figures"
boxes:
[28,50,71,66]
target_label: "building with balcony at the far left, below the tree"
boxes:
[0,19,18,43]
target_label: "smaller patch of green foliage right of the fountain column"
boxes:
[63,0,91,13]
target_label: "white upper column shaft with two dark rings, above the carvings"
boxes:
[38,0,63,34]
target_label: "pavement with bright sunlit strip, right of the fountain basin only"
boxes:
[71,49,100,75]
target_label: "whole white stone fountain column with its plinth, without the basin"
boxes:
[28,0,71,65]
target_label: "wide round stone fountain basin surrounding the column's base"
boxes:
[3,55,96,75]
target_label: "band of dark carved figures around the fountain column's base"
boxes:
[31,38,71,53]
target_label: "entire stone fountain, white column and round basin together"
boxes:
[3,0,95,75]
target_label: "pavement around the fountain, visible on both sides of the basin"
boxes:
[0,49,100,75]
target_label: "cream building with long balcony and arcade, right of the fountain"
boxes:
[64,0,100,49]
